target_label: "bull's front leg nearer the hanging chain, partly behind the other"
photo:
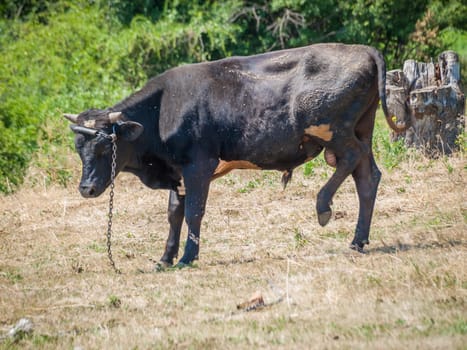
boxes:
[160,190,185,267]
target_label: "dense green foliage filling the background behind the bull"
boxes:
[0,0,467,192]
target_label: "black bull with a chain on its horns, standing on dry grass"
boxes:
[65,44,405,265]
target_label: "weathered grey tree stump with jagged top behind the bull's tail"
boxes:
[386,51,465,156]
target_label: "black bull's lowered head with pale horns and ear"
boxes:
[64,109,144,198]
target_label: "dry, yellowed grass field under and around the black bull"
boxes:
[0,152,467,349]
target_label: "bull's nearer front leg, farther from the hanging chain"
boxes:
[178,154,219,267]
